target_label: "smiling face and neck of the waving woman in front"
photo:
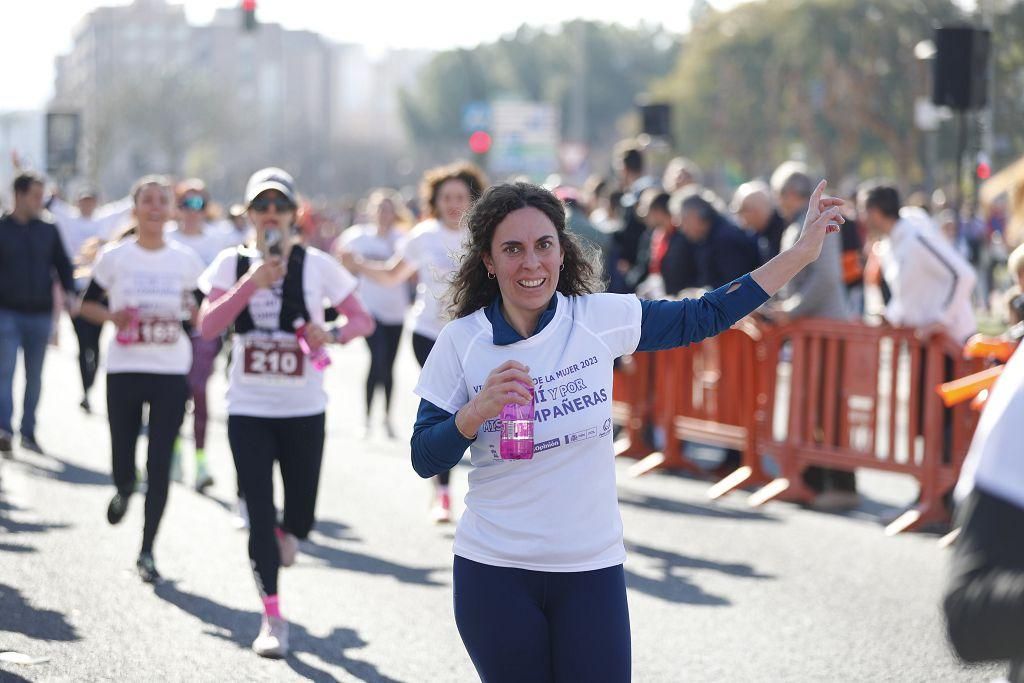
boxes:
[483,207,562,325]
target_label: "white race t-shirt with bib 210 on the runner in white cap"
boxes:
[200,247,357,418]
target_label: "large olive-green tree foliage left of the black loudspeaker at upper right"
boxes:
[653,0,957,182]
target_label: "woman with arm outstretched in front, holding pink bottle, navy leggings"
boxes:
[412,181,843,683]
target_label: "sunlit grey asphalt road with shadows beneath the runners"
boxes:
[0,321,1002,682]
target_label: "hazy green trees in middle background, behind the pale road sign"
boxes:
[401,20,679,157]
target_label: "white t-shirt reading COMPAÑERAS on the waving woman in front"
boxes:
[415,294,641,571]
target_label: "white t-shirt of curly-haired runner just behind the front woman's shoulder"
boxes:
[398,218,467,339]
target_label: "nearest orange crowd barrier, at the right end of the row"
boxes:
[750,319,983,535]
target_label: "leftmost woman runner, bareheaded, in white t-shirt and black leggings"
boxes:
[82,176,203,583]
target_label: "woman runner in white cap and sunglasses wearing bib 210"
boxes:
[200,168,374,657]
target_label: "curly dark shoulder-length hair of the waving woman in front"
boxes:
[449,182,601,319]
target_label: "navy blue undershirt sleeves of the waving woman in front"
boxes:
[411,275,768,478]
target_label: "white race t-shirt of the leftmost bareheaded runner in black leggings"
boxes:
[92,239,203,375]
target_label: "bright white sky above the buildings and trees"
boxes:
[0,0,757,111]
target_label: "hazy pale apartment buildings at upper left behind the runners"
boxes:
[51,0,430,199]
